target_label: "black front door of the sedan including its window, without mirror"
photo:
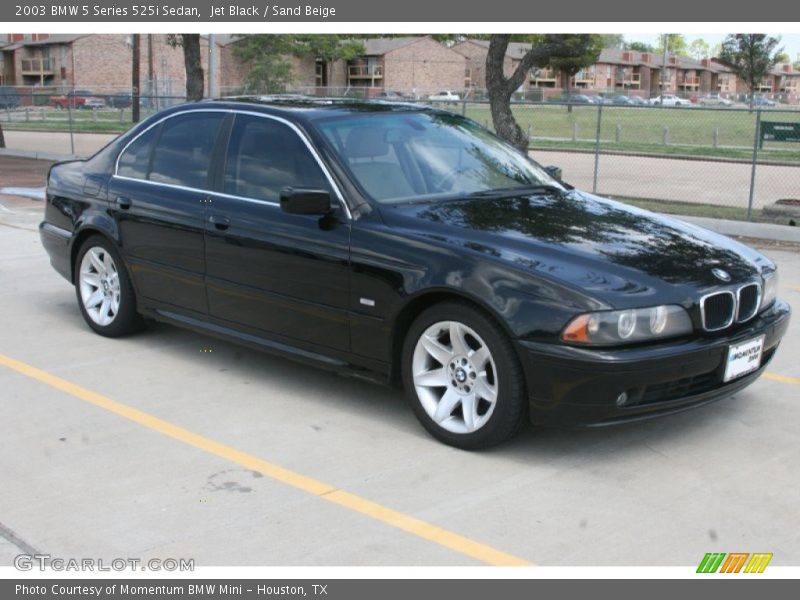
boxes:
[205,114,350,350]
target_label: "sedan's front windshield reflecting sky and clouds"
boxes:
[316,112,563,204]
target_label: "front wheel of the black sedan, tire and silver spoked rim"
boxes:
[402,302,527,450]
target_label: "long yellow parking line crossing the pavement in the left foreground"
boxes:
[0,354,532,566]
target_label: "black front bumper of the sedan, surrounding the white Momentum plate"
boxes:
[518,299,791,427]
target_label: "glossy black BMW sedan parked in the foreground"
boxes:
[40,98,791,449]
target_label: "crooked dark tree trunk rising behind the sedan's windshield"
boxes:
[486,35,529,152]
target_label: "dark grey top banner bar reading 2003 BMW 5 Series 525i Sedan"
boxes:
[0,0,800,22]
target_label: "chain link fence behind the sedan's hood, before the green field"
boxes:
[428,101,800,222]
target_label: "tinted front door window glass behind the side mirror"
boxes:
[223,115,330,202]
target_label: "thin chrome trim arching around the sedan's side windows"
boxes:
[113,108,353,220]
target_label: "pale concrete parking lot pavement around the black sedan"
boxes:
[0,185,800,566]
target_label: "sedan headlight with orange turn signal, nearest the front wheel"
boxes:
[561,305,693,345]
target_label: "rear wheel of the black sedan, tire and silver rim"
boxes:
[74,235,144,337]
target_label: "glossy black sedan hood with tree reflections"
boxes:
[382,190,772,304]
